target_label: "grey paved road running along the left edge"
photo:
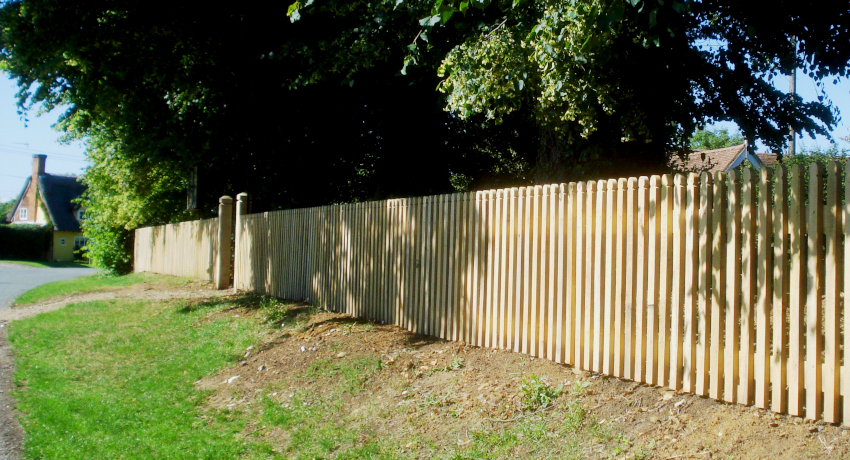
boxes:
[0,263,95,460]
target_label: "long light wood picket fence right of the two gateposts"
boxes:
[137,163,850,424]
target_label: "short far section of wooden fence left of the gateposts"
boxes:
[133,218,219,281]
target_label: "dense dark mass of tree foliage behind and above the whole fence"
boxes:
[0,0,850,274]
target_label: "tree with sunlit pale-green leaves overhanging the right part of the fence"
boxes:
[400,0,850,181]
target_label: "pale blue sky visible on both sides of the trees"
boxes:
[0,66,850,202]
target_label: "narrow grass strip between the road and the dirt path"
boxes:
[12,273,188,305]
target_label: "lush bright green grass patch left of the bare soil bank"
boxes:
[9,300,264,460]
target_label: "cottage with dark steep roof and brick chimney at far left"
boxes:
[6,155,86,262]
